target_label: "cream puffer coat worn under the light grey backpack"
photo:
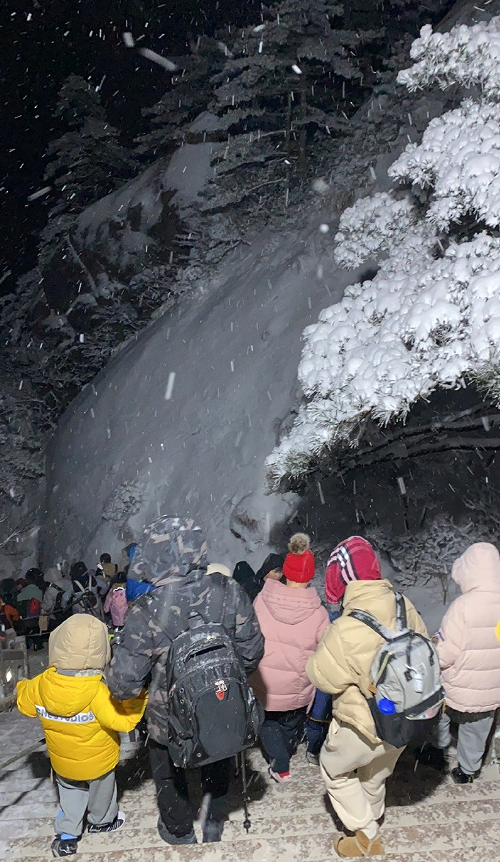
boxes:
[306,580,428,743]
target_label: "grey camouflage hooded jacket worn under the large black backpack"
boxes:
[106,517,264,744]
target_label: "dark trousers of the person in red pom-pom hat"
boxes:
[259,706,307,773]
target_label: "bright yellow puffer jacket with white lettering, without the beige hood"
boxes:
[17,667,146,781]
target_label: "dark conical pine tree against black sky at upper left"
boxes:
[44,74,136,215]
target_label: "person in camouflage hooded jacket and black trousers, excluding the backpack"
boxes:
[106,516,264,844]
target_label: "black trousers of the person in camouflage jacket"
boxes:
[148,738,231,838]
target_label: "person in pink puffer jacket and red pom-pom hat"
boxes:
[249,533,328,783]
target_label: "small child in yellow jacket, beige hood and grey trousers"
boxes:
[17,614,146,856]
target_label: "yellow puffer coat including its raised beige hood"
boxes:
[17,614,146,781]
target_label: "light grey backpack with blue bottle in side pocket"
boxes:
[349,593,444,748]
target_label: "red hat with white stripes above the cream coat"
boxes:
[325,536,382,604]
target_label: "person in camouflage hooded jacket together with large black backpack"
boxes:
[106,516,264,844]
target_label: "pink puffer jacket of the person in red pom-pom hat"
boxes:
[249,580,329,711]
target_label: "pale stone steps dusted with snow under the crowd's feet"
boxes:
[0,713,500,862]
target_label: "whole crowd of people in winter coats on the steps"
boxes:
[9,516,500,858]
